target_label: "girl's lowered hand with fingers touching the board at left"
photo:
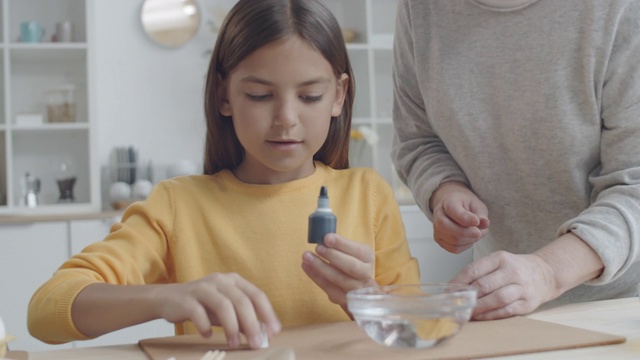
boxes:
[154,273,281,349]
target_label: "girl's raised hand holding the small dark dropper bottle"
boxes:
[302,234,377,313]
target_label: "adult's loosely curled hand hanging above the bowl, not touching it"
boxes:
[431,182,489,254]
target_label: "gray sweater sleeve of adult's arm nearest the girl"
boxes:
[391,1,469,219]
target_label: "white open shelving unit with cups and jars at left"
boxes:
[0,0,100,214]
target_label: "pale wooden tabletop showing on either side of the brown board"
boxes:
[21,298,640,360]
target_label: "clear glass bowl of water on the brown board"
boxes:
[347,284,476,349]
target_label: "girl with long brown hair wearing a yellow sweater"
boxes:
[28,0,419,348]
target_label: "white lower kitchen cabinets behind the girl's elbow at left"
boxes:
[0,218,174,351]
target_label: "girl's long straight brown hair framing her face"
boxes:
[204,0,355,174]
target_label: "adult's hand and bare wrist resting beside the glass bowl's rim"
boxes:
[451,233,604,320]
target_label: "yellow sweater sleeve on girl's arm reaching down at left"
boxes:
[27,186,173,344]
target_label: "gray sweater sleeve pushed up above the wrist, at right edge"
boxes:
[559,1,640,284]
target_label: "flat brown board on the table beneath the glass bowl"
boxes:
[139,317,626,360]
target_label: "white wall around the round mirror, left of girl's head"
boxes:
[91,0,235,166]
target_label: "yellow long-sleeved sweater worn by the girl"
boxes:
[28,163,419,343]
